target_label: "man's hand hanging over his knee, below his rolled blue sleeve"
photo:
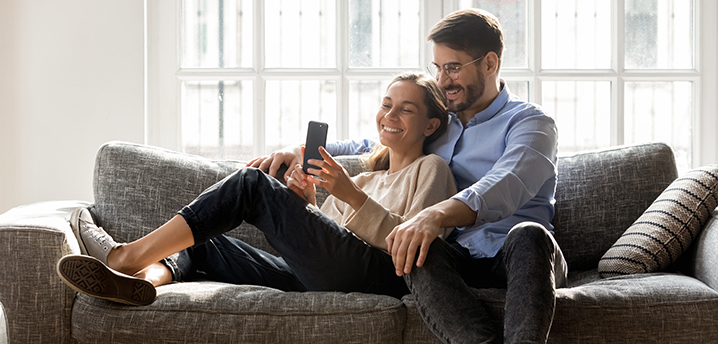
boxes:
[385,208,441,276]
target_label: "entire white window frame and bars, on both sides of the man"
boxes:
[145,0,718,167]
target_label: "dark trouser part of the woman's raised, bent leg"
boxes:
[180,168,408,296]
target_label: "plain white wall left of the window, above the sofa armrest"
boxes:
[0,0,144,213]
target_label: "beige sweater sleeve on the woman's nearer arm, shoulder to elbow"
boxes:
[345,155,456,251]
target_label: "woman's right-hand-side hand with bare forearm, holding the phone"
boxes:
[307,147,369,210]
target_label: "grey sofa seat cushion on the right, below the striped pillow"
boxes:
[403,269,718,344]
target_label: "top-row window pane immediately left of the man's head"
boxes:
[349,0,424,68]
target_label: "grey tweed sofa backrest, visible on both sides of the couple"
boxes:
[92,142,677,270]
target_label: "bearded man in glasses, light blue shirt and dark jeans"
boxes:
[251,10,566,343]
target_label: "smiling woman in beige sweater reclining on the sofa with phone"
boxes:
[57,74,456,305]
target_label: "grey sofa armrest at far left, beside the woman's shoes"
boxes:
[0,201,89,343]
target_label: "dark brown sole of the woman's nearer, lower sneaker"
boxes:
[57,255,157,306]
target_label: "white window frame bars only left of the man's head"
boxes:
[145,0,442,156]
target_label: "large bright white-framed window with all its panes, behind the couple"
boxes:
[146,0,717,171]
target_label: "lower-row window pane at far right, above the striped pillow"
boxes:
[624,81,693,171]
